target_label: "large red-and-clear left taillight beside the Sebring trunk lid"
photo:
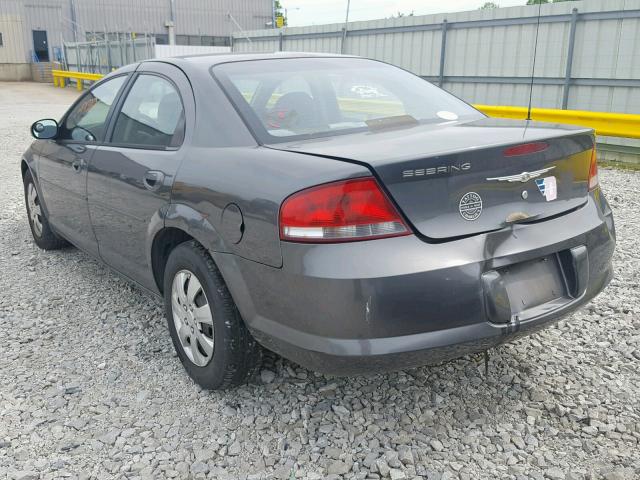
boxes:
[280,177,410,242]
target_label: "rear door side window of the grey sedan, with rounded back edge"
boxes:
[111,74,184,147]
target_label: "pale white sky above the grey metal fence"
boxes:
[280,0,527,27]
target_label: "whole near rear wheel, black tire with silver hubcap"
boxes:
[164,241,262,390]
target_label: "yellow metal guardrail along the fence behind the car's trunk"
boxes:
[474,105,640,138]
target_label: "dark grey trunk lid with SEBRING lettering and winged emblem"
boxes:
[270,118,594,240]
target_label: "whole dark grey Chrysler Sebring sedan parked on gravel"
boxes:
[21,54,615,389]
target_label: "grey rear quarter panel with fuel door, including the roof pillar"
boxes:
[165,60,371,266]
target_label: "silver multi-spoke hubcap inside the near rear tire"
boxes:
[171,270,214,367]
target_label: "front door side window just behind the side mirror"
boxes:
[58,75,127,142]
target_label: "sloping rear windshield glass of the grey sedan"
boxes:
[212,57,483,143]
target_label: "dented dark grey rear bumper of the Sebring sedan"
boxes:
[214,190,615,374]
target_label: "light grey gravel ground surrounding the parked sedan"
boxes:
[0,84,640,480]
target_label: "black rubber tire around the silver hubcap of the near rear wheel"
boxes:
[164,241,262,390]
